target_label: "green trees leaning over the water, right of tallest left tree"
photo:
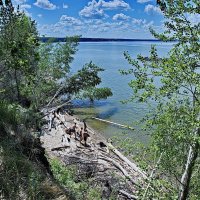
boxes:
[33,39,112,109]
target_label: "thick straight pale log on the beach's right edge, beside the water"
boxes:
[107,143,148,179]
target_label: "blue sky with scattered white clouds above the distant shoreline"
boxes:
[13,0,164,39]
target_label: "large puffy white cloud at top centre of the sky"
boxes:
[79,0,130,19]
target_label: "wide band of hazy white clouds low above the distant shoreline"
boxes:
[38,15,153,38]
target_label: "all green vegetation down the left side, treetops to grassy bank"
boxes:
[0,0,112,199]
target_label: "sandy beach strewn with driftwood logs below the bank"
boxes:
[40,113,146,199]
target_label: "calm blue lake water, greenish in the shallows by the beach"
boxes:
[72,42,173,143]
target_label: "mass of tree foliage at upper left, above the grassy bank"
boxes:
[0,1,112,111]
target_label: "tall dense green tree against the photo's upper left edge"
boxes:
[0,1,39,105]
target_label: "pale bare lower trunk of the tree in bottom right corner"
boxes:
[178,128,200,200]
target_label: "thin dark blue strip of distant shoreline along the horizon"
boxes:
[39,37,175,42]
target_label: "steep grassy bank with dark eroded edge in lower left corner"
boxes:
[0,101,69,200]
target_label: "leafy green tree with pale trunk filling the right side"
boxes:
[122,0,200,200]
